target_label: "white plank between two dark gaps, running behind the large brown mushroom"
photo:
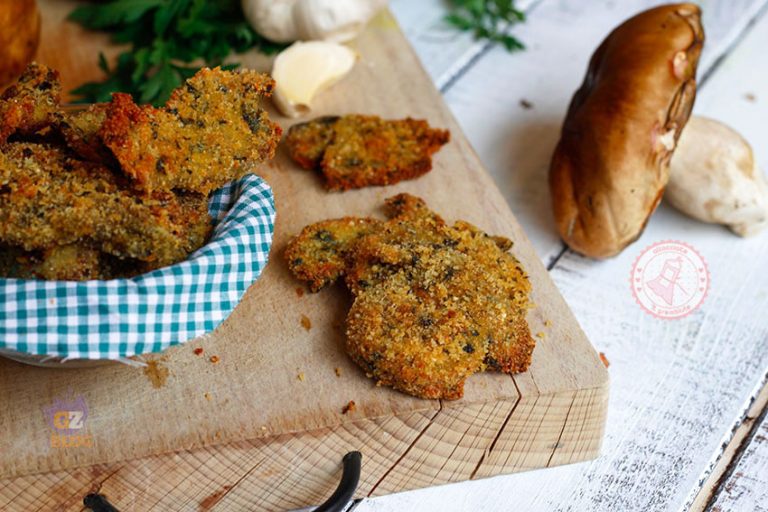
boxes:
[438,0,765,263]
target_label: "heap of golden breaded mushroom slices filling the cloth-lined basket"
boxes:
[0,64,280,280]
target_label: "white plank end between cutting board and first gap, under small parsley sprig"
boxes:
[390,0,537,89]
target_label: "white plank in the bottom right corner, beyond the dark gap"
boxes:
[709,408,768,512]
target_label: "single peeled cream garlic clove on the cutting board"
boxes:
[272,41,357,117]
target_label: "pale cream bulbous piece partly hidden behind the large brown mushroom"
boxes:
[664,116,768,236]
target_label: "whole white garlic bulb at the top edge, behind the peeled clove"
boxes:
[243,0,387,43]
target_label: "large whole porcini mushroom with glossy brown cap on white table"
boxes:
[549,3,704,258]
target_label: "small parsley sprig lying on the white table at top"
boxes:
[445,0,525,52]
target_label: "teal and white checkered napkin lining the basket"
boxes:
[0,175,275,359]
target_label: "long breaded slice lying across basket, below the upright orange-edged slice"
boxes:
[0,143,211,266]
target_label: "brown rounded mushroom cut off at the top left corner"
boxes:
[0,0,40,90]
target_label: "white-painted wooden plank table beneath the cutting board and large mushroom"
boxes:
[340,0,768,512]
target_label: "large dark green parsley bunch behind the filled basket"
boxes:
[69,0,284,105]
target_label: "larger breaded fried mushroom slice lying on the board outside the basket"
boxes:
[286,194,535,400]
